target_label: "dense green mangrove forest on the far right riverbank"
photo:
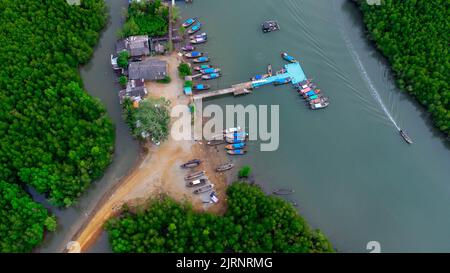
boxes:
[359,0,450,136]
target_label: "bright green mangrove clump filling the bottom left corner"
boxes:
[0,181,56,252]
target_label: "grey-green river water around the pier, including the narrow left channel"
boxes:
[40,0,450,252]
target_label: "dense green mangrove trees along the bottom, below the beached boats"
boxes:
[106,183,333,253]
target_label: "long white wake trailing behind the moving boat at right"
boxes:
[333,1,401,131]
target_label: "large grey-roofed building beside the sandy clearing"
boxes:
[128,59,168,81]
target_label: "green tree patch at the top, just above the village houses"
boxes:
[120,0,169,38]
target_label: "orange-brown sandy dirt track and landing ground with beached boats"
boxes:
[68,53,227,252]
